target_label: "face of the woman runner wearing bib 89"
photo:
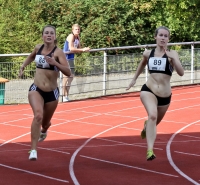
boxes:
[155,29,169,46]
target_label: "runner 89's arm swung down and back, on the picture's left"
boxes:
[126,50,150,90]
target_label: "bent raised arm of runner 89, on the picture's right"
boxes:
[166,50,184,76]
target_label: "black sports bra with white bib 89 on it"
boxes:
[147,49,174,76]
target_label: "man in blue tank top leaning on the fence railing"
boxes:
[63,24,90,102]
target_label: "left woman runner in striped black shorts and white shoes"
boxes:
[19,25,71,160]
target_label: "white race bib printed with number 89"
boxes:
[149,57,167,71]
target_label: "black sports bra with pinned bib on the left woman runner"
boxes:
[35,44,59,71]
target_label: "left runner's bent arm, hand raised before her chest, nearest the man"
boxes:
[45,48,71,76]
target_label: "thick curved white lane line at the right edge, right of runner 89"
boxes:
[166,120,200,185]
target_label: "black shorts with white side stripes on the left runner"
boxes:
[29,84,59,103]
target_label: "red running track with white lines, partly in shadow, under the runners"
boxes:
[0,85,200,185]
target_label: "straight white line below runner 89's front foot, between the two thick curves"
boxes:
[80,155,179,177]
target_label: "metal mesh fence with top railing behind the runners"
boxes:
[0,42,200,104]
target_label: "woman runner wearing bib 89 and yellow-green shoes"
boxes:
[127,26,184,161]
